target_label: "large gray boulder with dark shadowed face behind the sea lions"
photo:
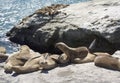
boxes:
[7,0,120,53]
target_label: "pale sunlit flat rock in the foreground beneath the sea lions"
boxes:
[0,63,120,83]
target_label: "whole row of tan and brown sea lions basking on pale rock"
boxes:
[0,42,120,74]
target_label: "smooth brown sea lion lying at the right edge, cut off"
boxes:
[94,56,120,71]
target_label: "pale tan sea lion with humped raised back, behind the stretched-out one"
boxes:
[4,45,35,72]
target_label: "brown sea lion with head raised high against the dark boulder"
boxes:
[56,42,95,63]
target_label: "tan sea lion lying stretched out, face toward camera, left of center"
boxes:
[12,53,57,74]
